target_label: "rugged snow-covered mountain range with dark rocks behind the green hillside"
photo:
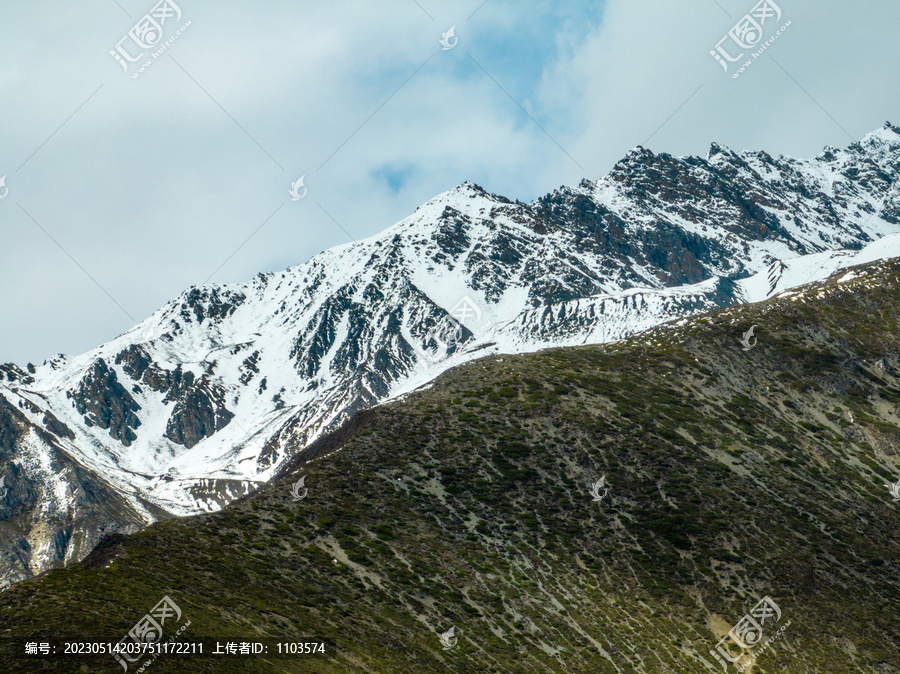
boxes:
[0,124,900,584]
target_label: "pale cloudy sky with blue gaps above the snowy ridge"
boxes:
[0,0,900,365]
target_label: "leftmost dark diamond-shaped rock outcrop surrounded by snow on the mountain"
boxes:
[66,358,141,447]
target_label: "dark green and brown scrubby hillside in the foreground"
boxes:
[0,260,900,674]
